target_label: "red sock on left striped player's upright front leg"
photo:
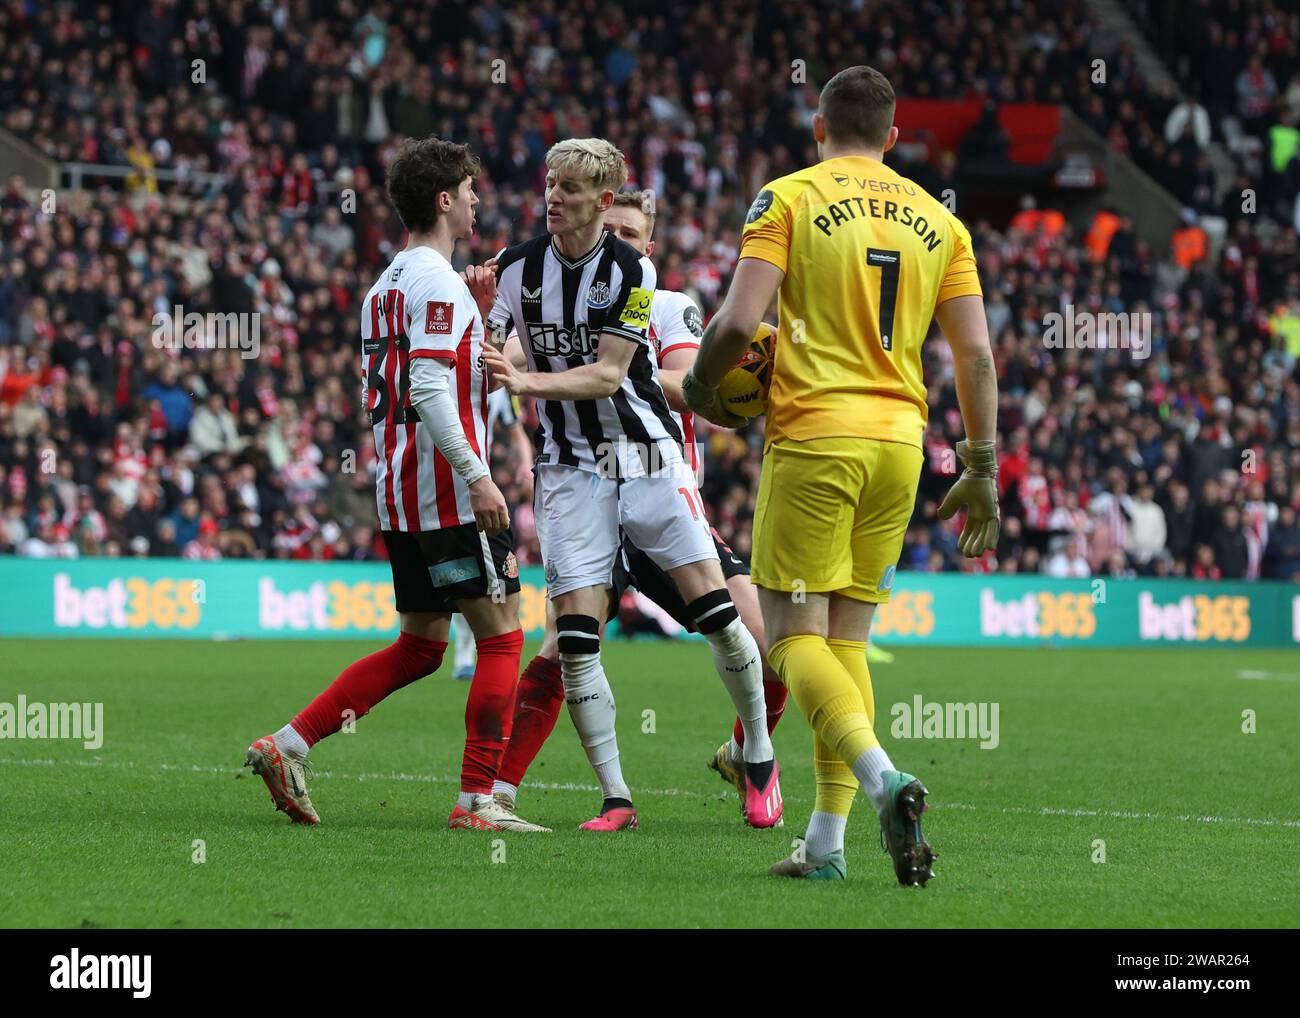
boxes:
[460,629,524,794]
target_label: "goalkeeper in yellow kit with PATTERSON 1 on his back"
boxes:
[683,66,1000,885]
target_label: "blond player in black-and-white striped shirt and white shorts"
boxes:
[484,138,780,831]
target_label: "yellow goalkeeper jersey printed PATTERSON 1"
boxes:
[740,156,983,446]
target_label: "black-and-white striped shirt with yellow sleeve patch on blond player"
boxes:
[488,233,683,477]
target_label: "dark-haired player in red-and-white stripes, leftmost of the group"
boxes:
[246,137,546,831]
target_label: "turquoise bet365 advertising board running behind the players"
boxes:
[0,558,1300,647]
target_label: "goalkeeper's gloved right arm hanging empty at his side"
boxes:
[935,295,1002,558]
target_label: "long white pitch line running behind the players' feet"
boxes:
[0,757,1300,828]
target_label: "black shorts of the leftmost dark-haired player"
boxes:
[382,523,519,615]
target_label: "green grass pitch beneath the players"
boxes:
[0,640,1300,928]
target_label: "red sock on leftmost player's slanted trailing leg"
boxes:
[293,633,447,746]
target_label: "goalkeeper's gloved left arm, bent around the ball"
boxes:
[681,257,785,428]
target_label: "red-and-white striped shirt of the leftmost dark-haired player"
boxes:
[361,247,488,530]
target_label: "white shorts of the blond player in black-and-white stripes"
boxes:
[533,463,718,598]
